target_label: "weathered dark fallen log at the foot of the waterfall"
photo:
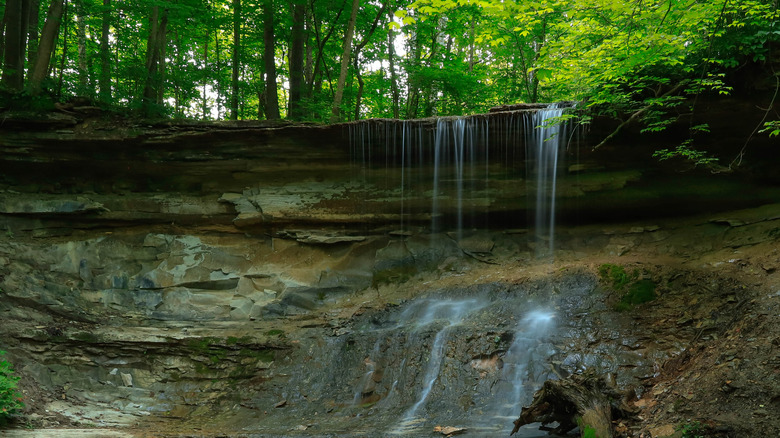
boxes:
[510,373,631,438]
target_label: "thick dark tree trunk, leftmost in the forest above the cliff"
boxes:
[2,0,27,92]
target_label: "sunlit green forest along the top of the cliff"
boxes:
[0,0,780,127]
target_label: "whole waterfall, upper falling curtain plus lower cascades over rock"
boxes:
[338,105,571,437]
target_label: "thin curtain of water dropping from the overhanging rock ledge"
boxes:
[349,105,572,252]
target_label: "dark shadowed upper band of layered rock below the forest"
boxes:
[0,107,778,236]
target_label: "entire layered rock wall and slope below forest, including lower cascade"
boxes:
[0,114,780,437]
